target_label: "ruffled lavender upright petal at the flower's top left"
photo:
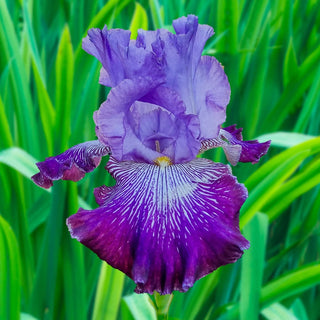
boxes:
[82,26,164,87]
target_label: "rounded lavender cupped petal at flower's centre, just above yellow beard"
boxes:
[94,78,200,163]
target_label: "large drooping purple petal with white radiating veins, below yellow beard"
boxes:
[67,158,249,294]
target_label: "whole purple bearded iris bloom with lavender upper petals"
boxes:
[32,15,270,294]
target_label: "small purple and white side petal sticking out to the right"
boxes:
[200,125,271,166]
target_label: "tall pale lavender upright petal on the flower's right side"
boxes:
[164,15,230,139]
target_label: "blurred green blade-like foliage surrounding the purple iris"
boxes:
[0,0,320,320]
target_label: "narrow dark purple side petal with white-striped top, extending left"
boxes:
[31,140,110,189]
